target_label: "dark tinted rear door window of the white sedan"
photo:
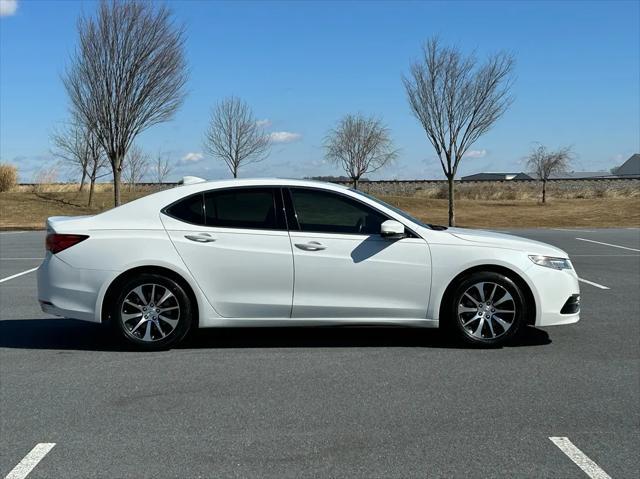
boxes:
[204,188,282,229]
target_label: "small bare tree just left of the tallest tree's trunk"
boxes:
[53,123,108,206]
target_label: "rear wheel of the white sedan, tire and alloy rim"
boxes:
[111,273,193,351]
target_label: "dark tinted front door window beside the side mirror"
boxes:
[291,188,387,234]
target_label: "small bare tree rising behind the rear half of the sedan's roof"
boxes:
[204,97,271,178]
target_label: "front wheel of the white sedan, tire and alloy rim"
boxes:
[448,271,527,347]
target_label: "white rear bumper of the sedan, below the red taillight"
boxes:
[37,253,112,322]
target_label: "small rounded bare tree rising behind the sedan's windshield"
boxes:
[324,114,398,189]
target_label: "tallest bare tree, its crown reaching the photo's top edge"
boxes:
[64,0,187,206]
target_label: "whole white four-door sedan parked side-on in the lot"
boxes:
[38,178,580,349]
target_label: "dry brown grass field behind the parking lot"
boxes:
[0,188,640,230]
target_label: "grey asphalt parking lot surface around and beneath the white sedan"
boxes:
[0,228,640,479]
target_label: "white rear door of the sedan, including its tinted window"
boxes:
[161,187,293,318]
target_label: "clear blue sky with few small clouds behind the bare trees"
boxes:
[0,0,640,181]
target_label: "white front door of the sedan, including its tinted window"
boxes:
[286,188,431,318]
